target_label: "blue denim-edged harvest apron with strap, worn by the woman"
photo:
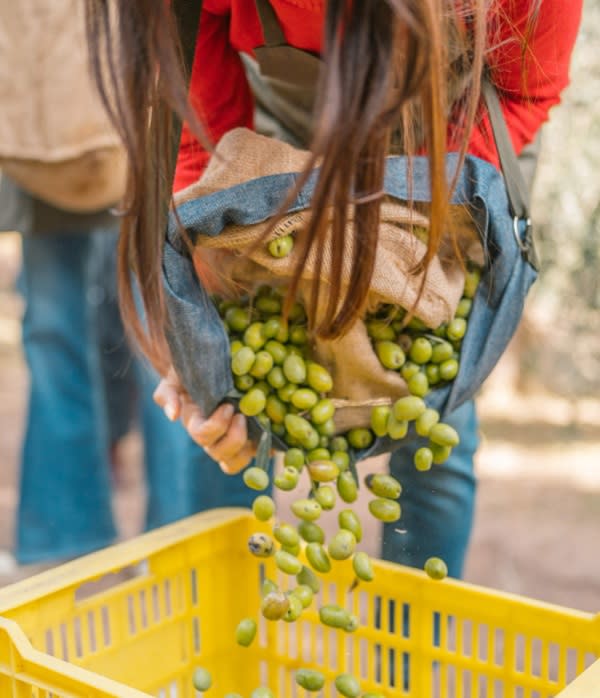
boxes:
[163,0,537,459]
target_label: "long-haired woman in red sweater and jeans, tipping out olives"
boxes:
[88,0,581,576]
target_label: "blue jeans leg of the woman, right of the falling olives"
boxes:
[382,401,479,578]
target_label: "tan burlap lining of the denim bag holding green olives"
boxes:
[176,129,474,431]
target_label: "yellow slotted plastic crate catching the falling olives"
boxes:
[0,510,600,698]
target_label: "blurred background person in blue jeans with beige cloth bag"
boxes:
[0,0,255,564]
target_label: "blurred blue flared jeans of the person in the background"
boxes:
[16,231,253,563]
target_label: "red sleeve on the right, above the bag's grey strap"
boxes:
[469,0,582,166]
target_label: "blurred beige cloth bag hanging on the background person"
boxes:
[0,0,125,211]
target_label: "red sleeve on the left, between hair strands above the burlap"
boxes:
[173,3,254,191]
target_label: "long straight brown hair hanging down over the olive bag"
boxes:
[86,0,516,370]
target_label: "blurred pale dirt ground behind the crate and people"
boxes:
[0,236,600,612]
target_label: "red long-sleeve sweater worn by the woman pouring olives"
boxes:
[174,0,583,191]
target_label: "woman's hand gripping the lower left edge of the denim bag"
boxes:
[154,368,256,475]
